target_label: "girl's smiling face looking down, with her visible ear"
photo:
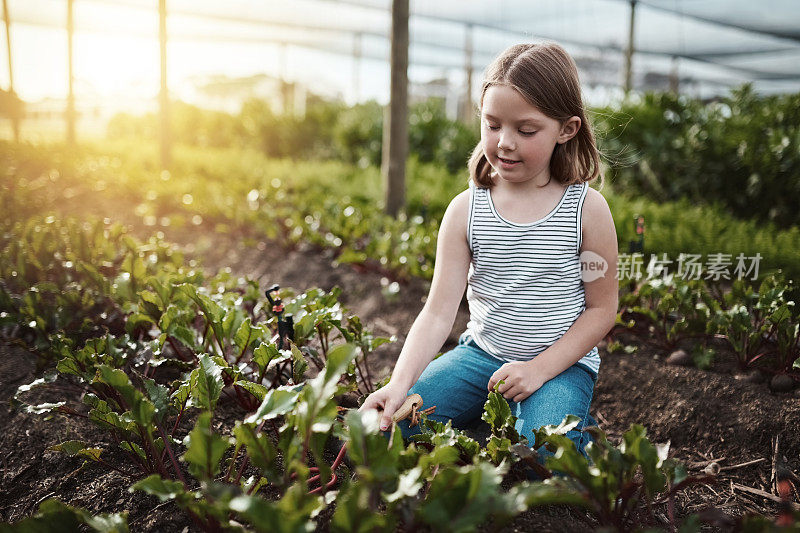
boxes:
[481,85,581,185]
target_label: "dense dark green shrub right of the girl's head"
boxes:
[596,85,800,227]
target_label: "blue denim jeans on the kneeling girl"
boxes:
[385,334,597,458]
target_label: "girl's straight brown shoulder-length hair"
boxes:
[468,42,602,188]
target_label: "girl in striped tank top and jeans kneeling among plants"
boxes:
[360,43,618,460]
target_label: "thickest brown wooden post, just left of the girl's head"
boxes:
[381,0,408,216]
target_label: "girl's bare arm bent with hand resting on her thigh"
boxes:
[488,188,619,402]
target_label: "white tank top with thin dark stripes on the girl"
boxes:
[466,182,600,373]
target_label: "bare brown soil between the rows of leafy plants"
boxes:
[0,233,800,532]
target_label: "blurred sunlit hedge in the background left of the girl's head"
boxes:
[108,97,480,172]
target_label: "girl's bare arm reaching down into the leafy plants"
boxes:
[359,190,472,429]
